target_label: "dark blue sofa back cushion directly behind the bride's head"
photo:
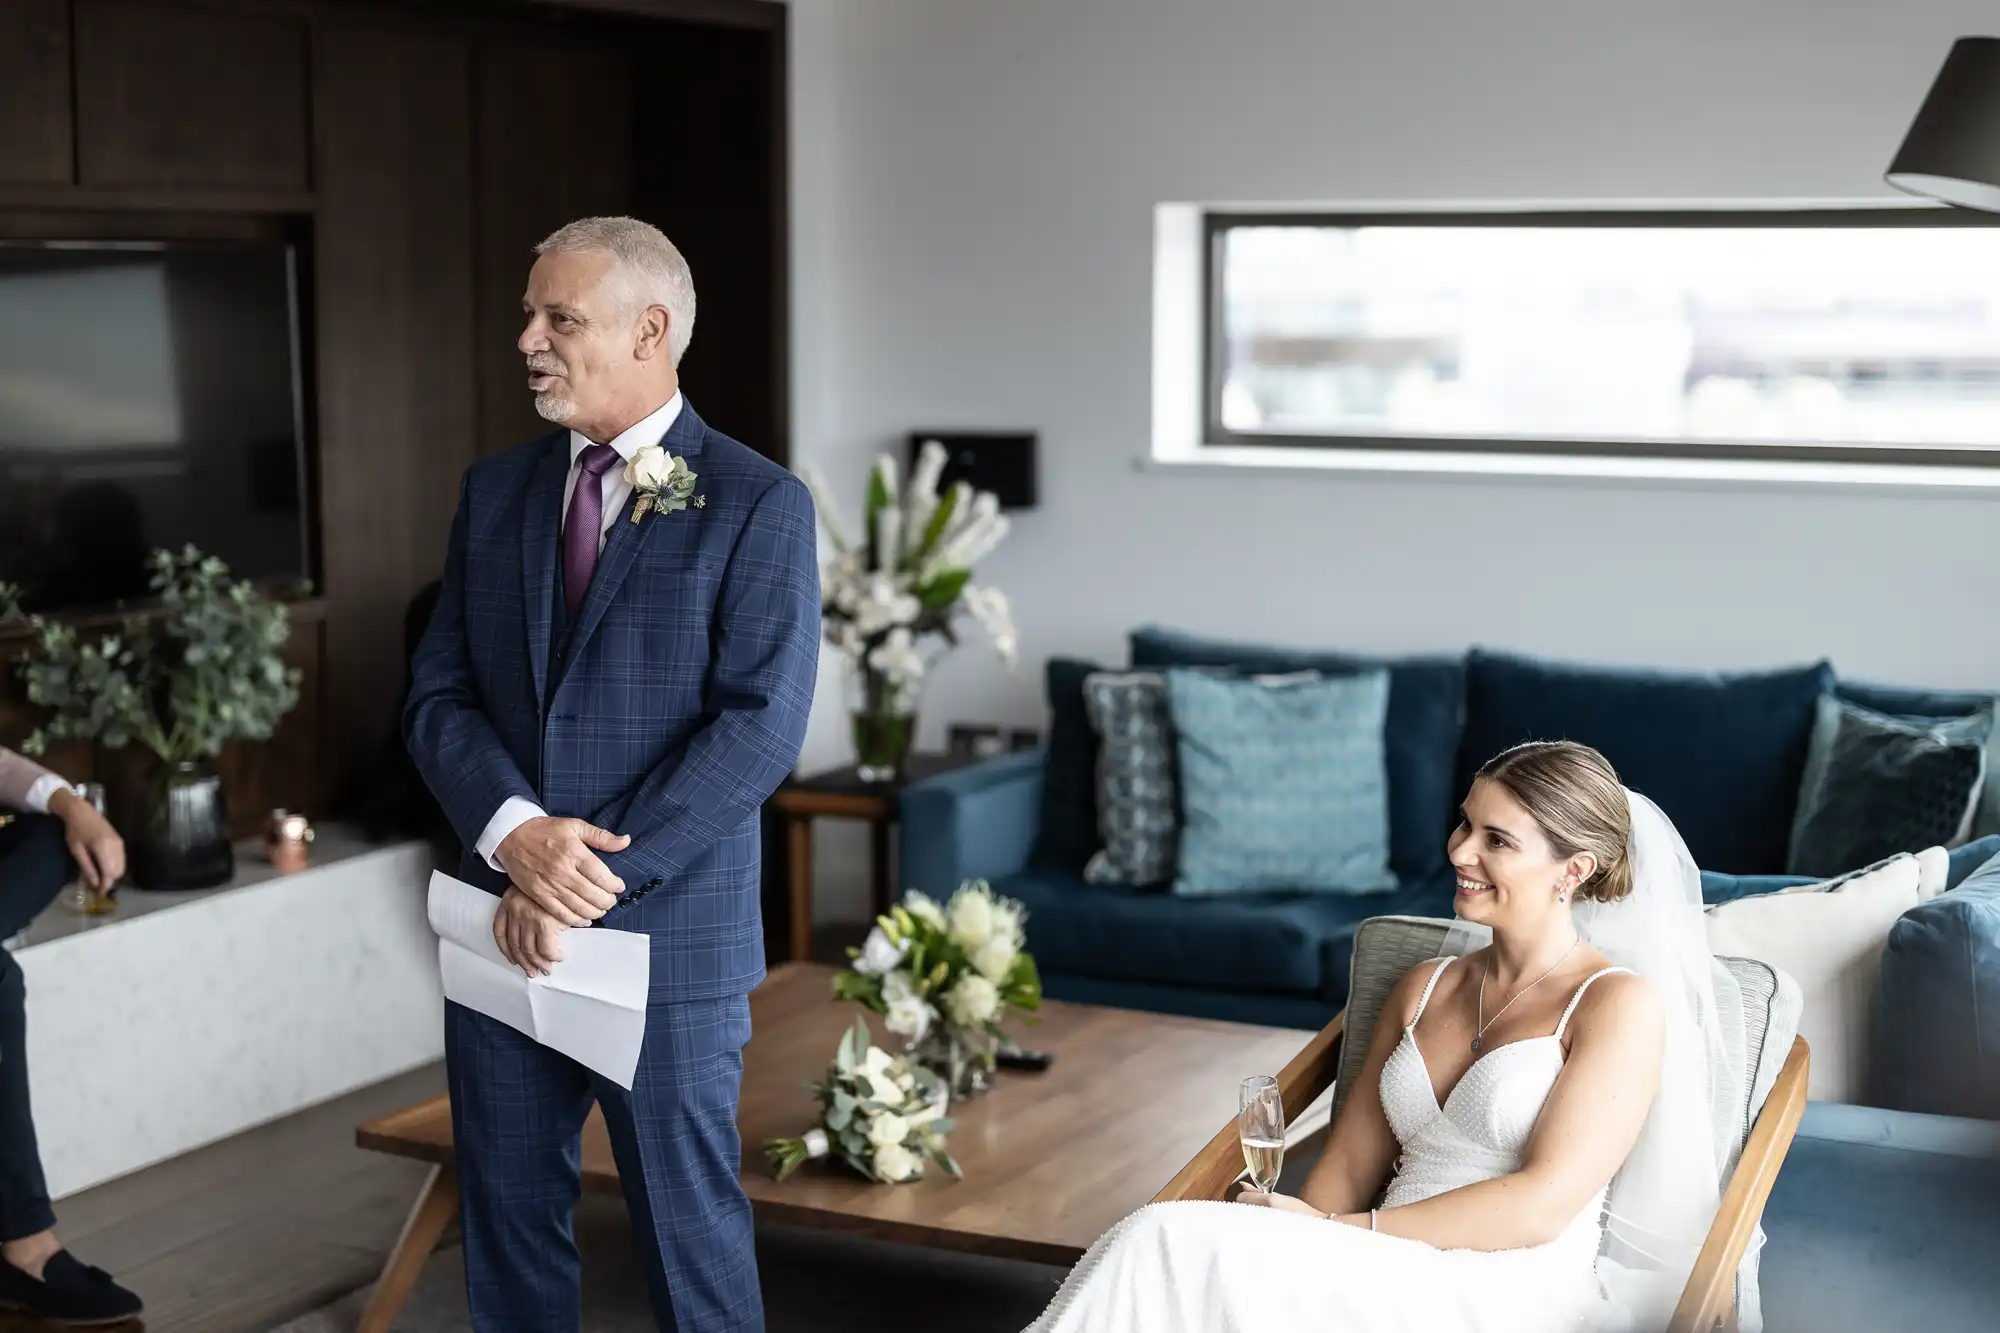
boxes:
[1458,648,1834,875]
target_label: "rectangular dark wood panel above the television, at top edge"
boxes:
[76,0,310,190]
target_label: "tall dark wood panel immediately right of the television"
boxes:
[314,26,476,771]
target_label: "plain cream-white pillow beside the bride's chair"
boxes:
[1708,853,1924,1103]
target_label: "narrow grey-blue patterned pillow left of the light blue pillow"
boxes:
[1084,671,1180,885]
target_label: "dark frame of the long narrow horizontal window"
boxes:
[1196,206,2000,468]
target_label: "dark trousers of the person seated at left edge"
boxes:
[0,815,76,1241]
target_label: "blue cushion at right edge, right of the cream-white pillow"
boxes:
[1872,844,2000,1119]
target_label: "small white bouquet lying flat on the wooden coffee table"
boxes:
[764,1021,964,1185]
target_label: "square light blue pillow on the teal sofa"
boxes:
[1166,669,1396,897]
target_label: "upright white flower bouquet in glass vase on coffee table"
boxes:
[834,879,1042,1097]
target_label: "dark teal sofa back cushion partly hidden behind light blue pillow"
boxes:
[1132,624,1466,883]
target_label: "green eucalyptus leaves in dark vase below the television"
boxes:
[0,546,300,765]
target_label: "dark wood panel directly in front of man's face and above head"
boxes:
[472,36,632,454]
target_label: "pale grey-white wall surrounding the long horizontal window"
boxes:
[792,0,2000,915]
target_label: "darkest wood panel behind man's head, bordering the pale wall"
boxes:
[634,19,790,462]
